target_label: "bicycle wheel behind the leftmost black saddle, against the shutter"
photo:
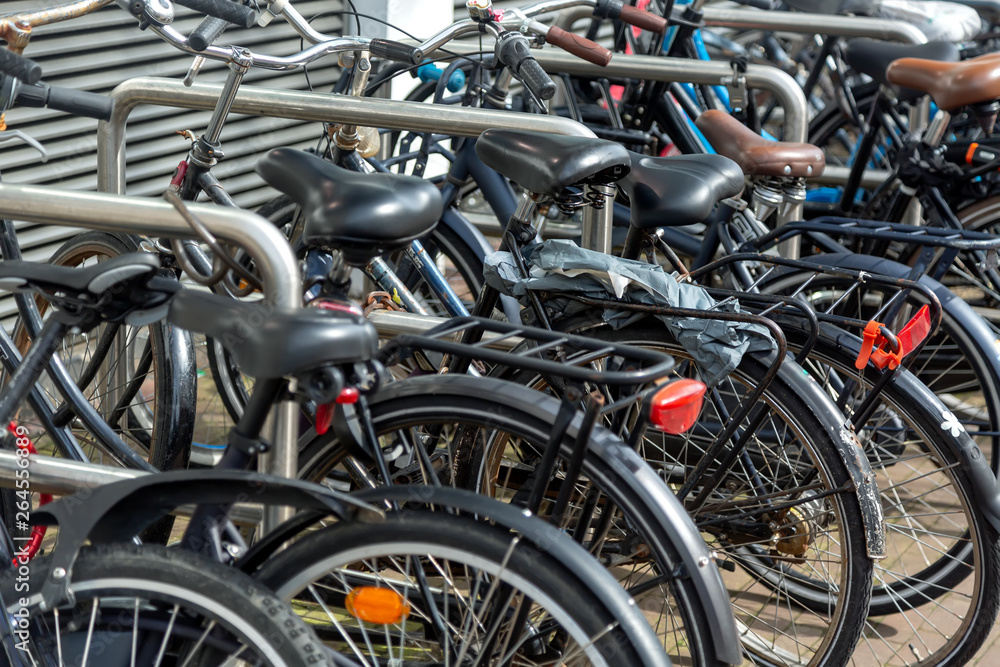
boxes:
[8,232,196,470]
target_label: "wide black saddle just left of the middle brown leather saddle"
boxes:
[621,153,743,229]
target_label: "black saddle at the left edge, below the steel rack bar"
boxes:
[0,253,160,297]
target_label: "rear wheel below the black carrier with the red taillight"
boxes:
[299,376,719,665]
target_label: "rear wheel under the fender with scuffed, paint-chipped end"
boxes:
[561,321,873,665]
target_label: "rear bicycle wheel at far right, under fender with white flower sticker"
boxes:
[786,327,1000,667]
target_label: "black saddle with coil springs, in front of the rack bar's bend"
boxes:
[476,130,629,199]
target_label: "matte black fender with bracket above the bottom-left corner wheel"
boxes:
[28,470,384,609]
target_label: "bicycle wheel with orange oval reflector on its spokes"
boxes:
[255,510,656,666]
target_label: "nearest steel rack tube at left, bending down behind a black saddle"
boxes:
[0,183,302,525]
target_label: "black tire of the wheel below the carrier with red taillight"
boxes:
[299,375,719,665]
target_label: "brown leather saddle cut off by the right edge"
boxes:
[885,54,1000,111]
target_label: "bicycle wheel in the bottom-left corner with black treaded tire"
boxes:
[0,544,329,667]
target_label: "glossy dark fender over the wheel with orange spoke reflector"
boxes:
[353,485,672,667]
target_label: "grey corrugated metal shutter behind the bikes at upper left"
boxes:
[0,0,342,317]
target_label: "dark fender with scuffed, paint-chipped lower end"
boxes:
[762,353,886,560]
